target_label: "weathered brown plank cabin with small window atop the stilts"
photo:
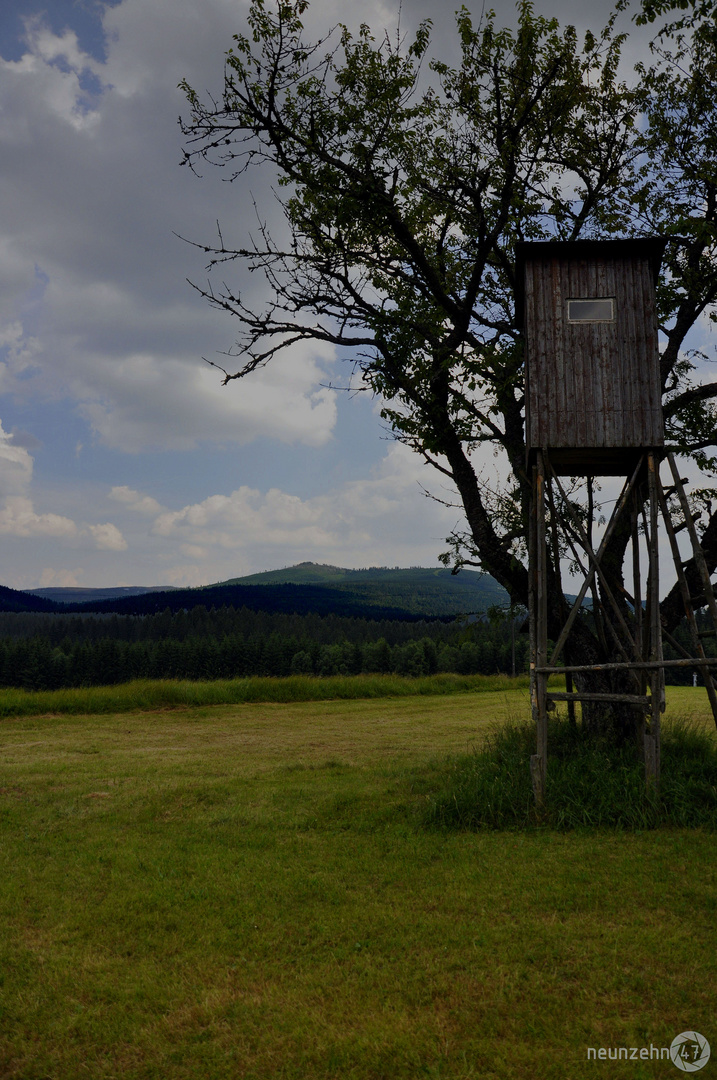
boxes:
[516,238,665,476]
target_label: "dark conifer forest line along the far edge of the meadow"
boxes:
[0,606,528,690]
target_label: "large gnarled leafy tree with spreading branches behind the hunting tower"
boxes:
[181,0,717,723]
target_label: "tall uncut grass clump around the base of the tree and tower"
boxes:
[423,717,717,829]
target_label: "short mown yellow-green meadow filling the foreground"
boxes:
[0,688,717,1080]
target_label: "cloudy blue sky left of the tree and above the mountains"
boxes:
[0,0,704,589]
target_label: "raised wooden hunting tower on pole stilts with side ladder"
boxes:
[516,238,717,805]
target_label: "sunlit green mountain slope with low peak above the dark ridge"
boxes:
[215,563,508,616]
